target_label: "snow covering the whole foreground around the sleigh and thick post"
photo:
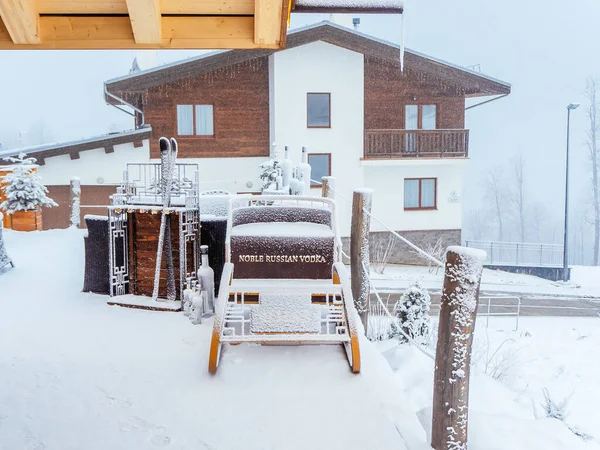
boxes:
[0,230,600,450]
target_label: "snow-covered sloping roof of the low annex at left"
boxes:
[0,127,152,165]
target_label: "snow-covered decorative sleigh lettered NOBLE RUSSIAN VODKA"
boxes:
[208,195,360,373]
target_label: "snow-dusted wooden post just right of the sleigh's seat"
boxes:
[350,189,373,333]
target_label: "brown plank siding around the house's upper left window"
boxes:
[142,57,269,158]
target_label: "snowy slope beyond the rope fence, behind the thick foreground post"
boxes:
[377,317,600,450]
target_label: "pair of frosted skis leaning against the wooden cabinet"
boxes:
[152,137,177,301]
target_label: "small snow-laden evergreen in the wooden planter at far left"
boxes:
[0,153,58,214]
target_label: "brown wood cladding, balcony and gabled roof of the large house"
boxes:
[106,23,510,162]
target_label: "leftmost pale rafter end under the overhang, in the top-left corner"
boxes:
[0,0,40,44]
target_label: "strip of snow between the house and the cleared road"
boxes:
[372,265,600,298]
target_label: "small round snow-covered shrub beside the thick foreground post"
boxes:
[394,283,431,345]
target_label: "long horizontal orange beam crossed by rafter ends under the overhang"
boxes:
[0,15,278,50]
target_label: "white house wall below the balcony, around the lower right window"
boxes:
[363,160,468,231]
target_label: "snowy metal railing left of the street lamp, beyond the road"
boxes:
[465,241,563,267]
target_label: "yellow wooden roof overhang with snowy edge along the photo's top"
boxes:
[0,0,403,50]
